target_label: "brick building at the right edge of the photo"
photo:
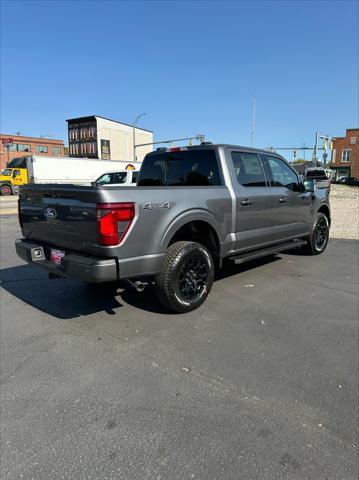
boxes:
[330,128,359,179]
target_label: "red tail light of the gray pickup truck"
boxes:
[96,202,135,245]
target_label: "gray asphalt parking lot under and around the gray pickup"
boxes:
[1,215,359,480]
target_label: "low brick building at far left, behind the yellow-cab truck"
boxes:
[0,133,64,170]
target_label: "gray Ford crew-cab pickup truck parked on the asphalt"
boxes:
[16,143,330,312]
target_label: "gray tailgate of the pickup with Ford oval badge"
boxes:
[19,185,101,251]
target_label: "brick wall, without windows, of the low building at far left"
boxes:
[0,133,64,170]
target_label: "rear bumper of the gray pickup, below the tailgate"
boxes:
[15,239,119,283]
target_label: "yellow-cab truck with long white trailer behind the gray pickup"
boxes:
[0,155,141,195]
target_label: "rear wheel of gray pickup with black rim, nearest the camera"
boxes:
[155,241,214,313]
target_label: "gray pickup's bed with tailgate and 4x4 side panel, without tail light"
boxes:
[19,184,231,259]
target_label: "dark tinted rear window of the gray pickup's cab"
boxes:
[137,150,222,187]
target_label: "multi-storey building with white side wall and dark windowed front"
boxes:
[66,115,153,162]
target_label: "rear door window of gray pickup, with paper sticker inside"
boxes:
[231,152,267,187]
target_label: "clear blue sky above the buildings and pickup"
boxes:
[1,0,359,159]
